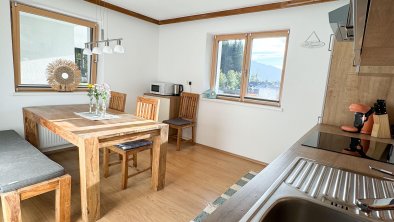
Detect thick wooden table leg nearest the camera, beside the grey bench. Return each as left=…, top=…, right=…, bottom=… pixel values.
left=79, top=138, right=100, bottom=222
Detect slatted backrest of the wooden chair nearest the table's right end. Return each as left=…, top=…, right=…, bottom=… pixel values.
left=135, top=96, right=160, bottom=121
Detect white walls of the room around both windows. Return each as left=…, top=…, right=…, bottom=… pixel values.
left=0, top=0, right=345, bottom=162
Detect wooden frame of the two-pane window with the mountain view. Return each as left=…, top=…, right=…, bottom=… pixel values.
left=210, top=29, right=290, bottom=107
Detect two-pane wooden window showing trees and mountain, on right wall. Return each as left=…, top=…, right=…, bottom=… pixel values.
left=211, top=30, right=289, bottom=106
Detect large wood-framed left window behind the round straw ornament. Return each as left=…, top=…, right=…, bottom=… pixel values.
left=12, top=3, right=97, bottom=91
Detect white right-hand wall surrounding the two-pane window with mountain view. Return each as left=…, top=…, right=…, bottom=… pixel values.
left=158, top=1, right=344, bottom=163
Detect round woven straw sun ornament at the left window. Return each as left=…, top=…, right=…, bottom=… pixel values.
left=47, top=59, right=81, bottom=92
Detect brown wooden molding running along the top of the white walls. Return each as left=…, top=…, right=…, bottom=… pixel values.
left=85, top=0, right=335, bottom=25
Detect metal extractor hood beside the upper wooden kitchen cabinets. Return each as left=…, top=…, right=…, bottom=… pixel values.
left=328, top=4, right=354, bottom=41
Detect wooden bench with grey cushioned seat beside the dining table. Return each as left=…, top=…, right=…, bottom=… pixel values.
left=0, top=130, right=71, bottom=222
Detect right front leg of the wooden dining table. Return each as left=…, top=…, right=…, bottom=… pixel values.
left=151, top=126, right=168, bottom=191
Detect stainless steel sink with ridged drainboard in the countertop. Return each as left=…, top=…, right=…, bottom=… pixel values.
left=241, top=158, right=394, bottom=222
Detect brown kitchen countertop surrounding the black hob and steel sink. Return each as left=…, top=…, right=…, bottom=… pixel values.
left=204, top=124, right=394, bottom=222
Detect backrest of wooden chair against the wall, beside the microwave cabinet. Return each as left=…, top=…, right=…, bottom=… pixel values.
left=179, top=92, right=200, bottom=121
